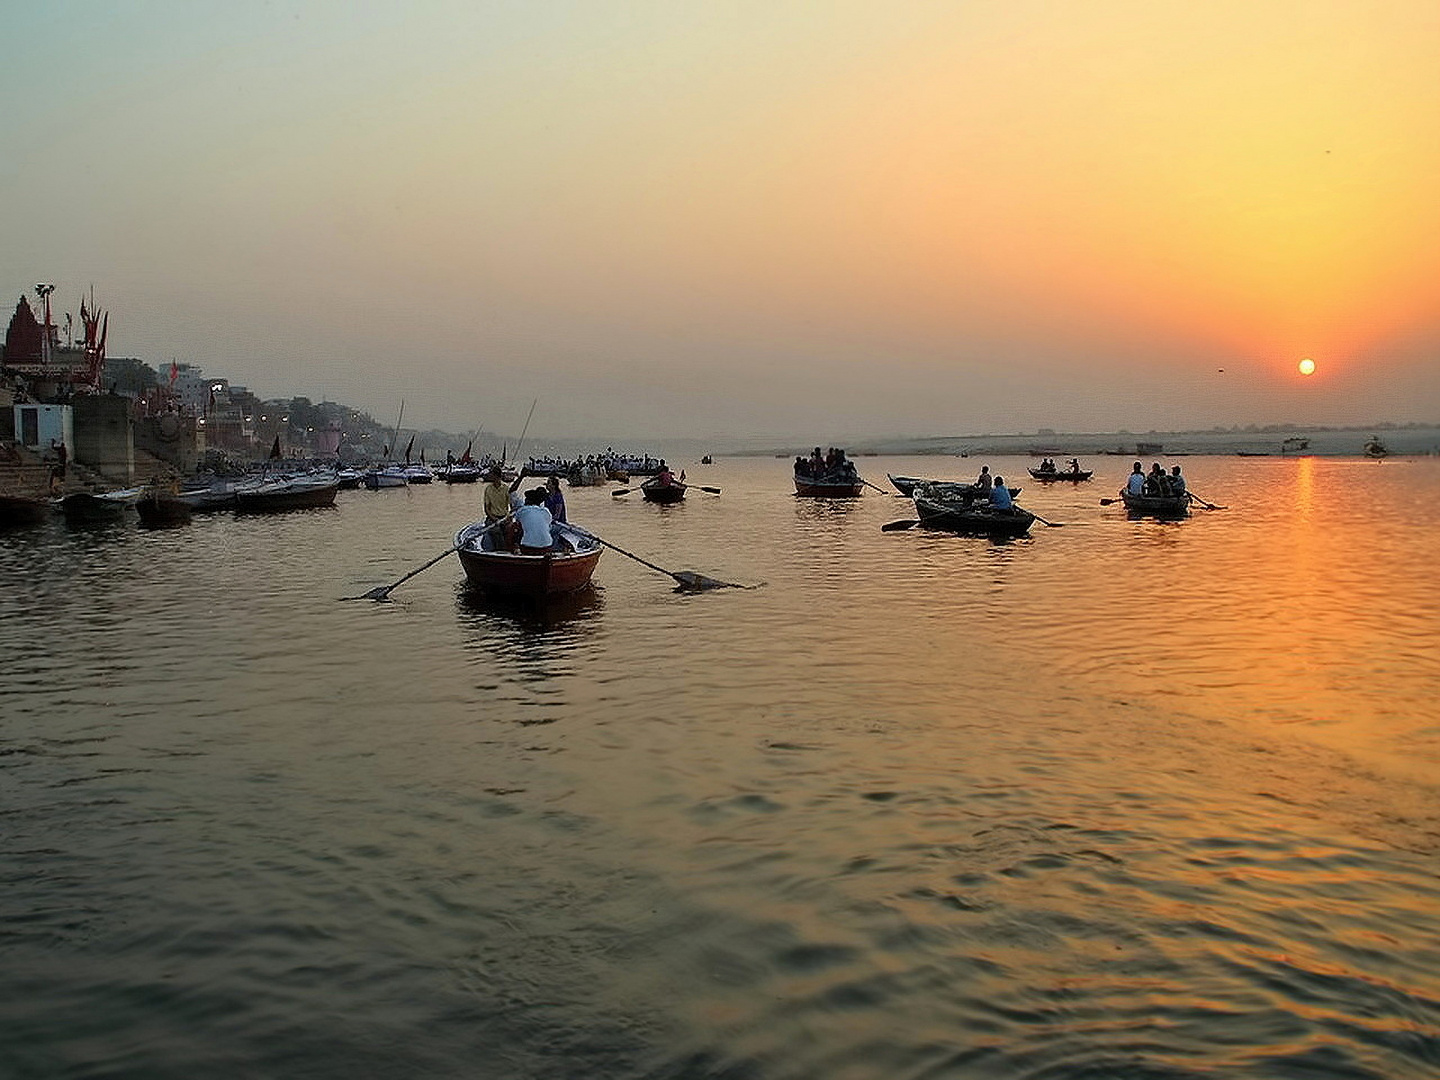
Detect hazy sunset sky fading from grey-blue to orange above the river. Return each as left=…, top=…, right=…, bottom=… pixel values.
left=0, top=0, right=1440, bottom=442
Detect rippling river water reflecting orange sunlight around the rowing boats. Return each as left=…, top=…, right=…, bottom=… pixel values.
left=0, top=456, right=1440, bottom=1080
